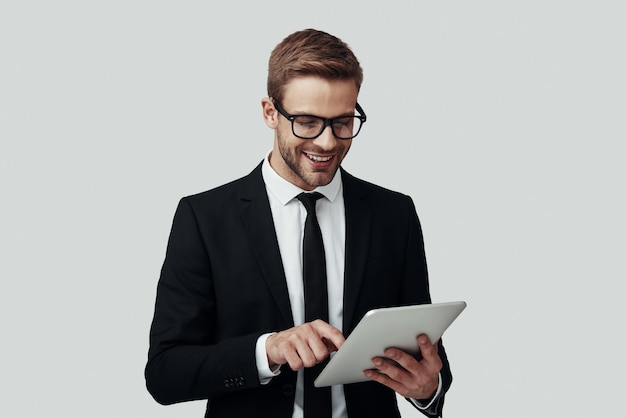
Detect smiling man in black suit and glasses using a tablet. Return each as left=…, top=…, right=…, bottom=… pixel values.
left=146, top=29, right=452, bottom=418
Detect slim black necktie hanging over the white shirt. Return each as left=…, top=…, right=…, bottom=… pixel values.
left=298, top=192, right=332, bottom=418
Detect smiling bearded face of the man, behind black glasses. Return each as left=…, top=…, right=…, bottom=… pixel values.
left=263, top=76, right=358, bottom=190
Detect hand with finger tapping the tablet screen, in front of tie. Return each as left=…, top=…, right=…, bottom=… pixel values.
left=265, top=319, right=346, bottom=371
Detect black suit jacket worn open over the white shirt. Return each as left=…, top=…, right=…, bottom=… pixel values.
left=145, top=165, right=452, bottom=418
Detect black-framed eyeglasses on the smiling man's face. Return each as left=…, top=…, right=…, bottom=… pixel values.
left=274, top=100, right=367, bottom=139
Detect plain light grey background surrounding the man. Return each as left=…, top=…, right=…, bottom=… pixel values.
left=0, top=0, right=626, bottom=418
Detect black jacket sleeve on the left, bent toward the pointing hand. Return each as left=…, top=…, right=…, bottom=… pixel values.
left=145, top=198, right=261, bottom=404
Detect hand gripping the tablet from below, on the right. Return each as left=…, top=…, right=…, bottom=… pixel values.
left=365, top=335, right=442, bottom=399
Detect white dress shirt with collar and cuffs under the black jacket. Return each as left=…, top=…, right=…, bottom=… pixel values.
left=256, top=154, right=442, bottom=418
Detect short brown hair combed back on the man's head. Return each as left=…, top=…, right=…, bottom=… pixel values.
left=267, top=29, right=363, bottom=101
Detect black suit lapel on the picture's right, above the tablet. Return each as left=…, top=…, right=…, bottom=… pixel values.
left=342, top=169, right=372, bottom=334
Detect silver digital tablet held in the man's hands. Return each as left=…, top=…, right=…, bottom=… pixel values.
left=315, top=301, right=466, bottom=387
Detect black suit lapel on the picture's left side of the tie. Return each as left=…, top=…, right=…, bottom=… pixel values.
left=240, top=164, right=293, bottom=327
